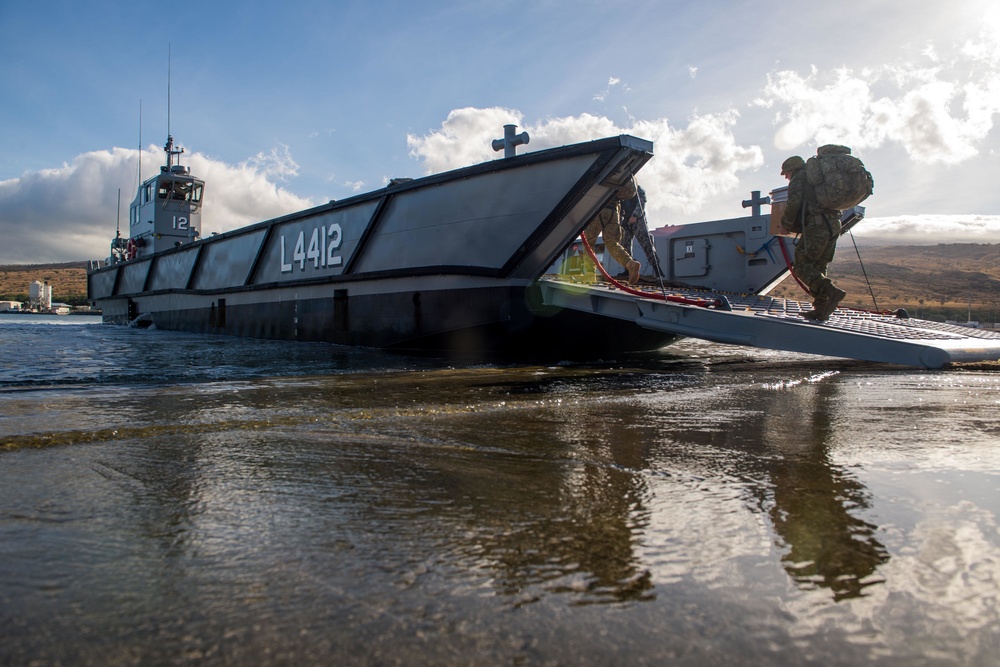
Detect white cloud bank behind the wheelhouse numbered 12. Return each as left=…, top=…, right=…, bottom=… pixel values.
left=0, top=147, right=312, bottom=264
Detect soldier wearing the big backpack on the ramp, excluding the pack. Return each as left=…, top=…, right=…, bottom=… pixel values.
left=781, top=155, right=847, bottom=322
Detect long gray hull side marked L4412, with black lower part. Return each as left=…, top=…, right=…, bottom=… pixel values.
left=88, top=136, right=676, bottom=356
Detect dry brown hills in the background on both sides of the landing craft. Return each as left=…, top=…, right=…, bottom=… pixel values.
left=0, top=247, right=1000, bottom=322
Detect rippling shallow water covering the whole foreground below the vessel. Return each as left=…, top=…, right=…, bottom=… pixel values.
left=0, top=316, right=1000, bottom=665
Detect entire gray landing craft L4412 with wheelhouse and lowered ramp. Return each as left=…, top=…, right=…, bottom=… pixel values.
left=88, top=128, right=1000, bottom=367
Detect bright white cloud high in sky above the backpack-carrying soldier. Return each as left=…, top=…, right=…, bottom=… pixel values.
left=752, top=30, right=1000, bottom=165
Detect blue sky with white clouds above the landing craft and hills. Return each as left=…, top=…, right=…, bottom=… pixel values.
left=0, top=0, right=1000, bottom=264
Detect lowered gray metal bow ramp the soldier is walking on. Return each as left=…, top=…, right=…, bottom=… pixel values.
left=538, top=276, right=1000, bottom=368
